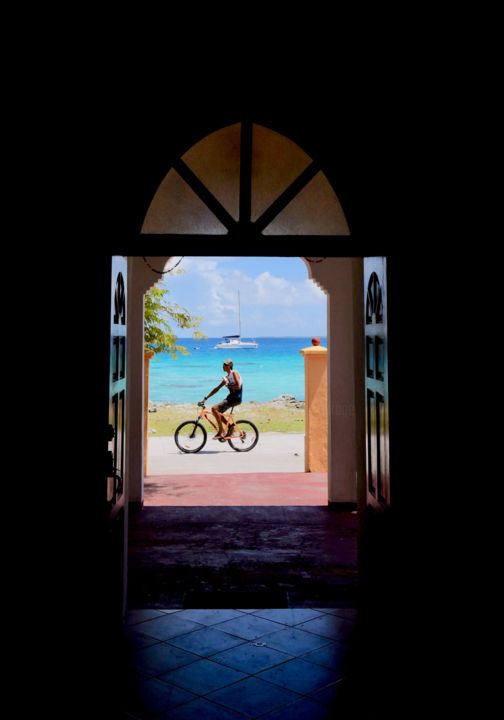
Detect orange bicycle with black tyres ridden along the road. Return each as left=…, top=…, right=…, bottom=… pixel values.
left=174, top=402, right=259, bottom=453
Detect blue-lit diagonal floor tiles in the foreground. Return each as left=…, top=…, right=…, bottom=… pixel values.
left=124, top=607, right=356, bottom=720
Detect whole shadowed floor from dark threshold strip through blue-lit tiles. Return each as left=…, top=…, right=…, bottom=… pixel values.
left=123, top=506, right=358, bottom=720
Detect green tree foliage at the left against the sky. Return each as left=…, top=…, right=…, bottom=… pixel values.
left=144, top=286, right=206, bottom=358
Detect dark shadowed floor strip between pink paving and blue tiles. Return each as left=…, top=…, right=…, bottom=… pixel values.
left=128, top=507, right=357, bottom=609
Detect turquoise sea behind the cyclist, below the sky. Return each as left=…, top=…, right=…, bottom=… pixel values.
left=149, top=337, right=327, bottom=403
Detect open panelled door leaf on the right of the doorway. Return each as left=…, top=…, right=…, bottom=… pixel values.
left=364, top=257, right=390, bottom=510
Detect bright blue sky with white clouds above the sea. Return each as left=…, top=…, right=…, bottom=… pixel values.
left=162, top=256, right=327, bottom=338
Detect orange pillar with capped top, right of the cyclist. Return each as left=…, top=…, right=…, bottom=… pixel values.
left=299, top=346, right=328, bottom=472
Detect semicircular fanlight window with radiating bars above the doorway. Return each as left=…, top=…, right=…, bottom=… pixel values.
left=142, top=122, right=350, bottom=239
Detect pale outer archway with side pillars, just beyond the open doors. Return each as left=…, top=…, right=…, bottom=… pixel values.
left=127, top=253, right=365, bottom=507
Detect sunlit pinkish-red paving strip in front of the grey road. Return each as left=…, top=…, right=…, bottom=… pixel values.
left=144, top=472, right=327, bottom=507
